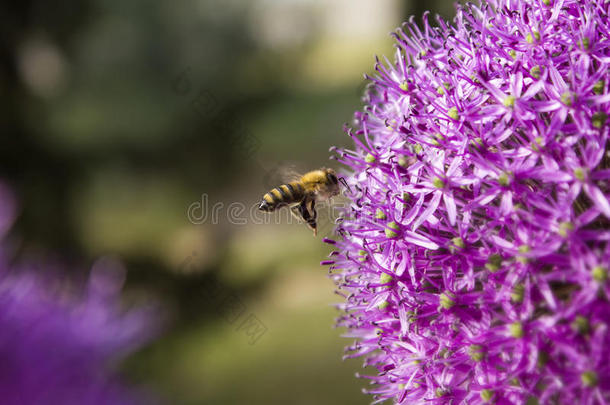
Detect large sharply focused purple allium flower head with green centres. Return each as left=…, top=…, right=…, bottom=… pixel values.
left=326, top=0, right=610, bottom=404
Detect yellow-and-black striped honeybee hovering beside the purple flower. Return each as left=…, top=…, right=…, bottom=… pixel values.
left=258, top=168, right=348, bottom=236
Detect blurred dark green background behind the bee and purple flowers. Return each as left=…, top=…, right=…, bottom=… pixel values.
left=0, top=0, right=453, bottom=404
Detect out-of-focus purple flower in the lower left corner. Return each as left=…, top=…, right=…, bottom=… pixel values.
left=0, top=184, right=158, bottom=405
